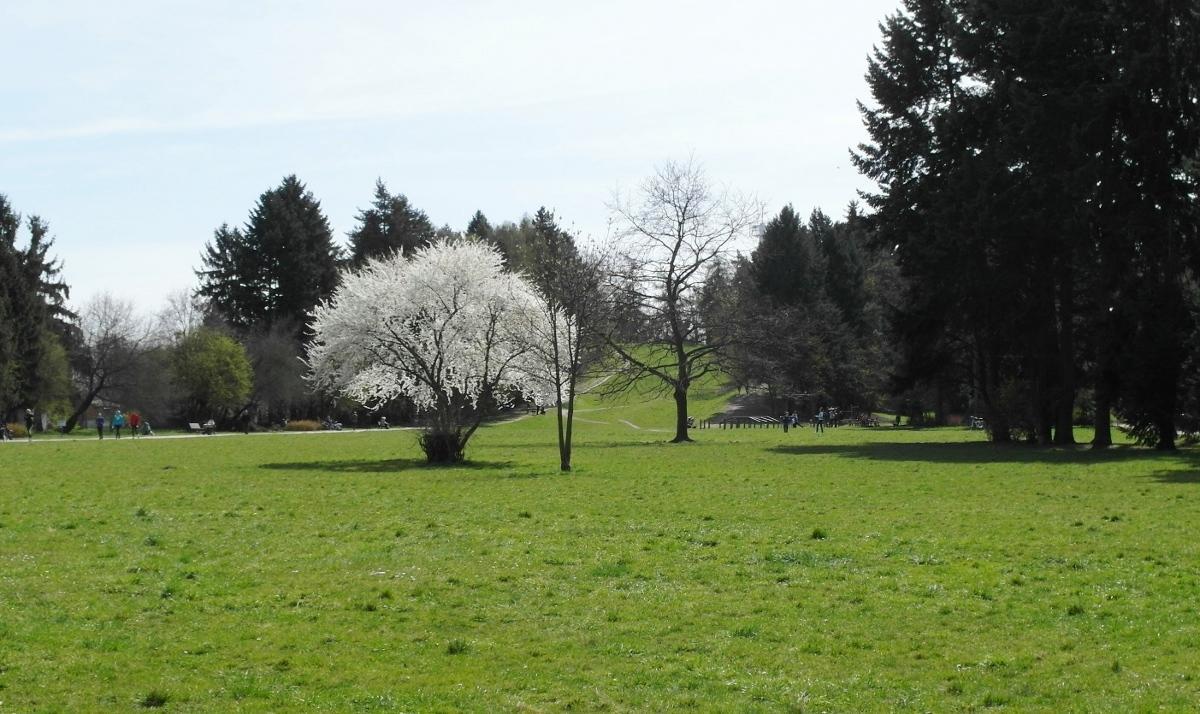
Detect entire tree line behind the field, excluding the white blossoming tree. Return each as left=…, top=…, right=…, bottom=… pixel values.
left=0, top=0, right=1200, bottom=456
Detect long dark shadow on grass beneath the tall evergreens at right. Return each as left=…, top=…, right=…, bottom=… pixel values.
left=772, top=442, right=1200, bottom=474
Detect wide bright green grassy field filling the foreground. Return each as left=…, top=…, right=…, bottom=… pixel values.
left=0, top=394, right=1200, bottom=712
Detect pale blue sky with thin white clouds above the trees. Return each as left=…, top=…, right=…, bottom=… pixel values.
left=0, top=0, right=899, bottom=313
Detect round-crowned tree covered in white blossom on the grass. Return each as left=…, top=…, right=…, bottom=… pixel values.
left=307, top=240, right=550, bottom=463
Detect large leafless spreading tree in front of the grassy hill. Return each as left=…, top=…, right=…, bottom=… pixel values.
left=607, top=160, right=760, bottom=442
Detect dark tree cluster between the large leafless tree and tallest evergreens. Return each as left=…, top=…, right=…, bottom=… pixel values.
left=701, top=205, right=896, bottom=412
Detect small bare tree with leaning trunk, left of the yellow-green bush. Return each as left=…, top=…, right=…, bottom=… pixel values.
left=66, top=293, right=151, bottom=431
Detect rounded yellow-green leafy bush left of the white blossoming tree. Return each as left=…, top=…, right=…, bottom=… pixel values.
left=173, top=328, right=252, bottom=419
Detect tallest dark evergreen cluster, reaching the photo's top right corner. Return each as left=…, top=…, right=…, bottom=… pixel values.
left=856, top=0, right=1200, bottom=448
